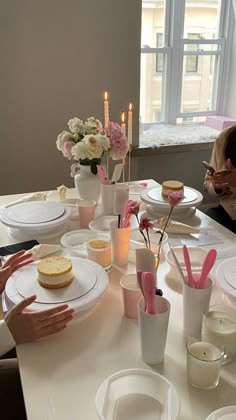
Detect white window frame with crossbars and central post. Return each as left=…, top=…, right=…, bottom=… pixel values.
left=141, top=0, right=232, bottom=124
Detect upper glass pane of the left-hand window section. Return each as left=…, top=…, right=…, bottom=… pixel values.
left=141, top=0, right=165, bottom=48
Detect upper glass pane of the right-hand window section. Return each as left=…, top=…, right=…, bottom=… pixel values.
left=183, top=0, right=221, bottom=39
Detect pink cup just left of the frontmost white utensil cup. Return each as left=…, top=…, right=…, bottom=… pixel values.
left=120, top=274, right=142, bottom=319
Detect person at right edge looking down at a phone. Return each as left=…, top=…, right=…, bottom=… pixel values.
left=204, top=125, right=236, bottom=233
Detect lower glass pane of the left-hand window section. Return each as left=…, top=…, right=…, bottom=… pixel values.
left=140, top=53, right=164, bottom=123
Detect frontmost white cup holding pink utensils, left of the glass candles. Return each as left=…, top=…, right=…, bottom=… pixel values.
left=138, top=296, right=170, bottom=365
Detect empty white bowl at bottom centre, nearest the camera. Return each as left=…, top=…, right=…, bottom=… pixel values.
left=96, top=369, right=180, bottom=420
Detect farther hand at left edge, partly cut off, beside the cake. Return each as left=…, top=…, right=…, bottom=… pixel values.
left=0, top=250, right=33, bottom=294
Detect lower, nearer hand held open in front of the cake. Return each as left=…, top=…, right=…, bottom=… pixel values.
left=5, top=295, right=74, bottom=344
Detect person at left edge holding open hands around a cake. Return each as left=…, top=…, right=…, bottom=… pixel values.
left=0, top=251, right=74, bottom=420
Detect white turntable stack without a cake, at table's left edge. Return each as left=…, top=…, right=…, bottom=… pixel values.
left=0, top=201, right=72, bottom=241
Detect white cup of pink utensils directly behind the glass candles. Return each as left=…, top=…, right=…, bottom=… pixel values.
left=183, top=277, right=213, bottom=340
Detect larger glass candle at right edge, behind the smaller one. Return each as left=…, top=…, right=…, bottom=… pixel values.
left=202, top=305, right=236, bottom=363
